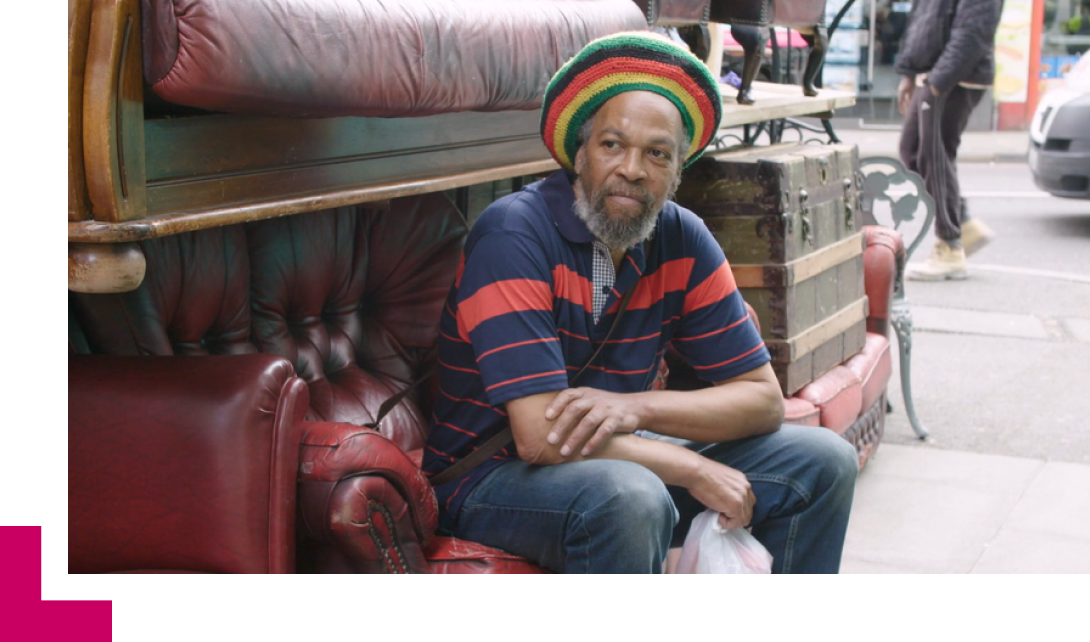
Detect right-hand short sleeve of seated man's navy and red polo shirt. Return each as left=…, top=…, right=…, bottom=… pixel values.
left=674, top=217, right=772, bottom=384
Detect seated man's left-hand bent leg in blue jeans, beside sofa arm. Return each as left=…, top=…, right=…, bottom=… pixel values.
left=450, top=461, right=677, bottom=574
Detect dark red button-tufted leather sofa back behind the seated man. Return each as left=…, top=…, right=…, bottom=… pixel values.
left=69, top=194, right=467, bottom=452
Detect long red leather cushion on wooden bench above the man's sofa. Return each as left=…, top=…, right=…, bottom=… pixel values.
left=143, top=0, right=647, bottom=118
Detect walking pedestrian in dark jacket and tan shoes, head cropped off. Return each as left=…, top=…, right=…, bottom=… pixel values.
left=896, top=0, right=1003, bottom=281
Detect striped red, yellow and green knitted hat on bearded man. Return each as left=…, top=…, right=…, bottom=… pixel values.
left=542, top=32, right=723, bottom=171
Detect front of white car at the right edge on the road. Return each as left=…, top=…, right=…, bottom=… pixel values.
left=1029, top=53, right=1090, bottom=198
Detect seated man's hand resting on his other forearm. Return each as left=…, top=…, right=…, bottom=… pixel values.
left=545, top=388, right=640, bottom=458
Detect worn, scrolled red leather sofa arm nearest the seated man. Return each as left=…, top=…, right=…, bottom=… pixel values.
left=299, top=423, right=439, bottom=573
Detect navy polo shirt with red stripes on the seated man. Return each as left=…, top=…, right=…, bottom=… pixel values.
left=424, top=170, right=771, bottom=519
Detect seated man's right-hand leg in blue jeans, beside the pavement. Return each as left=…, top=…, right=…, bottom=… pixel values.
left=649, top=426, right=859, bottom=574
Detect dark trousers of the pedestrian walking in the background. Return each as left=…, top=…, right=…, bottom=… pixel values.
left=900, top=80, right=984, bottom=242
